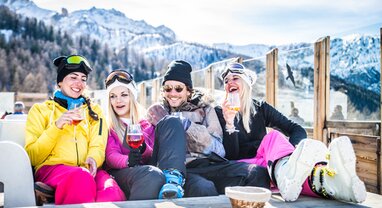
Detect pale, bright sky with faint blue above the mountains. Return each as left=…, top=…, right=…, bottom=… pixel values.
left=33, top=0, right=382, bottom=45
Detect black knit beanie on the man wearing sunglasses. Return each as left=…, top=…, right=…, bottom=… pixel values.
left=162, top=60, right=192, bottom=89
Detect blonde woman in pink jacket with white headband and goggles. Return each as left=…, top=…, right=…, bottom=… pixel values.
left=106, top=70, right=165, bottom=200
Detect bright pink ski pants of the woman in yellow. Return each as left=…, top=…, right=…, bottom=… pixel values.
left=35, top=164, right=126, bottom=204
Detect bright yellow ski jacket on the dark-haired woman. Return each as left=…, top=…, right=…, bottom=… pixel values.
left=25, top=100, right=108, bottom=171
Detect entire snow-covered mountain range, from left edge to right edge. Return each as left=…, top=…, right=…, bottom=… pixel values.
left=0, top=0, right=381, bottom=116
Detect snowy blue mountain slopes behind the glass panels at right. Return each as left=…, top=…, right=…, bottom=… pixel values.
left=216, top=34, right=381, bottom=119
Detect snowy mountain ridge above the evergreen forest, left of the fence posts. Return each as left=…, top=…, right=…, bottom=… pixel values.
left=0, top=0, right=242, bottom=68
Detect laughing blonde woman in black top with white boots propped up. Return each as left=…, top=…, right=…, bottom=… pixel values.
left=216, top=63, right=366, bottom=202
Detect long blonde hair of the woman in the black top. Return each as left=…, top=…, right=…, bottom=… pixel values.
left=240, top=77, right=256, bottom=133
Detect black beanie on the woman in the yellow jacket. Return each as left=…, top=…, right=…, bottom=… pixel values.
left=53, top=56, right=91, bottom=84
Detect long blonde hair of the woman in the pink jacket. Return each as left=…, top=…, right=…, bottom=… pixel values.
left=108, top=88, right=146, bottom=142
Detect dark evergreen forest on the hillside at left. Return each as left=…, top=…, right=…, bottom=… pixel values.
left=0, top=5, right=155, bottom=93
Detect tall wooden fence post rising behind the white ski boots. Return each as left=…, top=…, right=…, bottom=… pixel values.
left=313, top=36, right=330, bottom=144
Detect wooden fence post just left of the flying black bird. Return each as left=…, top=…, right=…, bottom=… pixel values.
left=265, top=48, right=278, bottom=107
